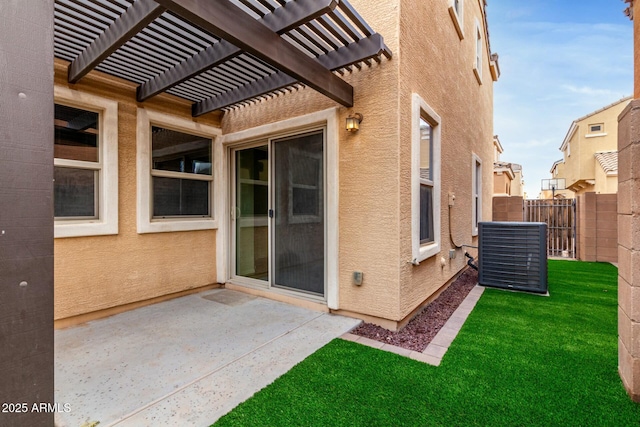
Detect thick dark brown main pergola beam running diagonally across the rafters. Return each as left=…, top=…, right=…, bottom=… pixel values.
left=157, top=0, right=353, bottom=107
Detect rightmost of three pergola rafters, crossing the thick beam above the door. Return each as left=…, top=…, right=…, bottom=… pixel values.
left=192, top=33, right=388, bottom=117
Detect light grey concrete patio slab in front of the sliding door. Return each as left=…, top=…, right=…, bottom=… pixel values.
left=55, top=289, right=359, bottom=427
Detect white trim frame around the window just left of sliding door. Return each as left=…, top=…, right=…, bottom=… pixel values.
left=136, top=108, right=225, bottom=234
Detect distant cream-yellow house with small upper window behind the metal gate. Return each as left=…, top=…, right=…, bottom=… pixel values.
left=559, top=97, right=631, bottom=195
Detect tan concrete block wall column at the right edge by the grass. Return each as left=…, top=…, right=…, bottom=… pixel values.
left=618, top=100, right=640, bottom=402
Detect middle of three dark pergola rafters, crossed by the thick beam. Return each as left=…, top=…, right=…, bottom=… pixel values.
left=136, top=0, right=337, bottom=102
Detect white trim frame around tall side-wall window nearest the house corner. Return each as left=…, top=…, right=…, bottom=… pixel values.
left=411, top=93, right=442, bottom=263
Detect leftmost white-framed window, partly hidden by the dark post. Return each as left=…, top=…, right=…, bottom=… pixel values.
left=53, top=86, right=118, bottom=237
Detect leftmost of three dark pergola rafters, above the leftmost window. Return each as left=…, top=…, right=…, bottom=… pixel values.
left=68, top=0, right=165, bottom=83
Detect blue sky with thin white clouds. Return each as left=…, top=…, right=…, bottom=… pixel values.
left=487, top=0, right=633, bottom=198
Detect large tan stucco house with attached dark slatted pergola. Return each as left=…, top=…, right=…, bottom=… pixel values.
left=54, top=0, right=500, bottom=328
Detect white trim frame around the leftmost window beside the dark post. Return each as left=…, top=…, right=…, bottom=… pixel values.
left=53, top=86, right=118, bottom=238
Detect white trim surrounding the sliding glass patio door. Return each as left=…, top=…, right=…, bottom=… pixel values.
left=216, top=108, right=344, bottom=310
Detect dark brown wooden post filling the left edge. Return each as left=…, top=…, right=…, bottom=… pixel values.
left=0, top=0, right=54, bottom=427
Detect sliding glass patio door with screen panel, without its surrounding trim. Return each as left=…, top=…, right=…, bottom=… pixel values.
left=232, top=130, right=325, bottom=297
